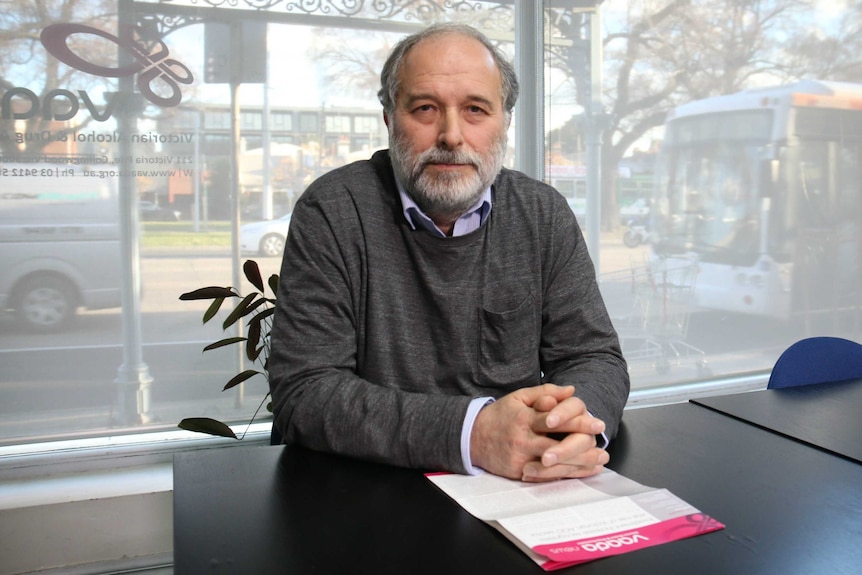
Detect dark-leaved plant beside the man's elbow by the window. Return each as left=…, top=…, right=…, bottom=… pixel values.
left=179, top=260, right=278, bottom=439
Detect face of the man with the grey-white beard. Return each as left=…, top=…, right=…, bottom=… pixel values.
left=386, top=31, right=508, bottom=224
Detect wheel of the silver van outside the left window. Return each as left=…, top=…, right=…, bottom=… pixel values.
left=15, top=276, right=77, bottom=333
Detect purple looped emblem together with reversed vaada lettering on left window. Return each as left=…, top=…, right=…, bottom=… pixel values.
left=0, top=22, right=194, bottom=122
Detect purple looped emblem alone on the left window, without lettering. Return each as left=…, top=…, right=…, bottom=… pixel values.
left=40, top=23, right=194, bottom=108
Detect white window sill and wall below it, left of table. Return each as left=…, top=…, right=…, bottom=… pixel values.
left=0, top=422, right=271, bottom=575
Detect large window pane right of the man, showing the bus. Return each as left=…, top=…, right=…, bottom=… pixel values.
left=544, top=0, right=862, bottom=390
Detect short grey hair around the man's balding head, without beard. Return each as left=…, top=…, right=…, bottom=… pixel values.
left=377, top=22, right=520, bottom=118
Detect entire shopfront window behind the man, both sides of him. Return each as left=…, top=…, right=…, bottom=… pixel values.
left=0, top=0, right=862, bottom=460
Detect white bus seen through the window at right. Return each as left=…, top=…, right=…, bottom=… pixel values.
left=636, top=83, right=862, bottom=388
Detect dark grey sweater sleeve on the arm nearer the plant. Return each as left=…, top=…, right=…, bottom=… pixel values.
left=269, top=182, right=470, bottom=472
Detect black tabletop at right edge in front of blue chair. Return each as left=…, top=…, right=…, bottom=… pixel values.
left=691, top=379, right=862, bottom=464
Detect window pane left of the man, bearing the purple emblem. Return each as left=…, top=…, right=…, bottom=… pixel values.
left=0, top=0, right=514, bottom=444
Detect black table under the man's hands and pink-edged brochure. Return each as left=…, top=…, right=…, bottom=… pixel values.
left=174, top=404, right=862, bottom=575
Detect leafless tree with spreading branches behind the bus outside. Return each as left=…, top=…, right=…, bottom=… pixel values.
left=552, top=0, right=811, bottom=229
